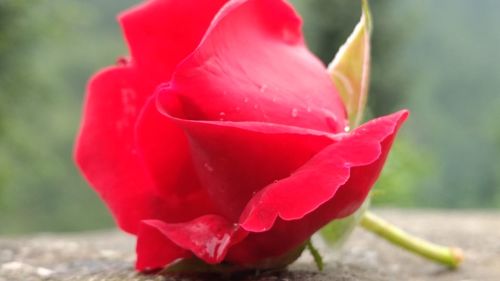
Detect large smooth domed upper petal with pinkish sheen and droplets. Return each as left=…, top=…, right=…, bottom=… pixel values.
left=160, top=0, right=346, bottom=132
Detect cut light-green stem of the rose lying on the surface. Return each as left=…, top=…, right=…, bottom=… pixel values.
left=360, top=211, right=463, bottom=268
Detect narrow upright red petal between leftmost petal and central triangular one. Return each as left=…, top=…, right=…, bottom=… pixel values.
left=136, top=99, right=214, bottom=222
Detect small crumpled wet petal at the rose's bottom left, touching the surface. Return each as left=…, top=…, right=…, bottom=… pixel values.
left=136, top=215, right=247, bottom=270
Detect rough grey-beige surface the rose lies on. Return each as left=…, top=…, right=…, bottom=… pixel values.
left=0, top=210, right=500, bottom=281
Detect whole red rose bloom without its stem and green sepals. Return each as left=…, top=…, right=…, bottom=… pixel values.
left=76, top=0, right=407, bottom=270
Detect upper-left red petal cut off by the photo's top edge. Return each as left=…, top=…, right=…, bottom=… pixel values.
left=119, top=0, right=226, bottom=80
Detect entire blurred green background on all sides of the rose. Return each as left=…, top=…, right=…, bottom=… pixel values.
left=0, top=0, right=500, bottom=234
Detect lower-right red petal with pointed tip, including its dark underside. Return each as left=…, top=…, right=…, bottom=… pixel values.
left=228, top=111, right=408, bottom=263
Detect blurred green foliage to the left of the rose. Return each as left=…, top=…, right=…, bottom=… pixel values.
left=0, top=0, right=141, bottom=232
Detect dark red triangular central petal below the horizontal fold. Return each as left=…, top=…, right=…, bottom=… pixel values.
left=158, top=91, right=333, bottom=221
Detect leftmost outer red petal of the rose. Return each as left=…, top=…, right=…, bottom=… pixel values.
left=75, top=67, right=166, bottom=233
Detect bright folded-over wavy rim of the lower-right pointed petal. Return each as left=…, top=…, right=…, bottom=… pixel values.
left=240, top=110, right=409, bottom=232
